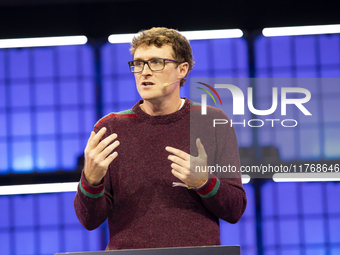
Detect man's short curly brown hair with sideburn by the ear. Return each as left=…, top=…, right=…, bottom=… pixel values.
left=130, top=27, right=195, bottom=87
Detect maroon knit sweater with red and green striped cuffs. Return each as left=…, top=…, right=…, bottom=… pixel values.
left=74, top=99, right=246, bottom=250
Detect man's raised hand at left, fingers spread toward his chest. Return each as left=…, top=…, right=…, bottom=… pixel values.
left=84, top=127, right=119, bottom=186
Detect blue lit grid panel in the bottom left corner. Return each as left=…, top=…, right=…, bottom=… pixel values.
left=0, top=192, right=104, bottom=255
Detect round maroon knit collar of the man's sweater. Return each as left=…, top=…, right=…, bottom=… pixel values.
left=132, top=97, right=192, bottom=124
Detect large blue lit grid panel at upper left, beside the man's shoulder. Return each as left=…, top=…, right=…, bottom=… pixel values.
left=0, top=45, right=96, bottom=173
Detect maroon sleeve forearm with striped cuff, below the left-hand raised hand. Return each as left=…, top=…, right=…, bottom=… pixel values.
left=74, top=125, right=113, bottom=230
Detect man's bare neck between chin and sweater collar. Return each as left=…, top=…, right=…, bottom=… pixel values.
left=140, top=97, right=182, bottom=116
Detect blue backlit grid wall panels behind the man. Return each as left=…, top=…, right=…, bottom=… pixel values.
left=0, top=34, right=340, bottom=255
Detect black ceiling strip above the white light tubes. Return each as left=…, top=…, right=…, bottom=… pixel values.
left=0, top=0, right=340, bottom=38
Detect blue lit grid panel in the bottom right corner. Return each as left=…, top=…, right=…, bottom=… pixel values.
left=261, top=182, right=340, bottom=254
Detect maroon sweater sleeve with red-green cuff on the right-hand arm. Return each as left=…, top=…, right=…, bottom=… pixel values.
left=196, top=109, right=247, bottom=223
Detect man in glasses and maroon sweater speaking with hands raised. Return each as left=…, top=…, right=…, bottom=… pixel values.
left=74, top=28, right=246, bottom=250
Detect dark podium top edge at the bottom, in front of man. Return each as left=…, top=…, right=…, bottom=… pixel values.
left=55, top=245, right=241, bottom=255
